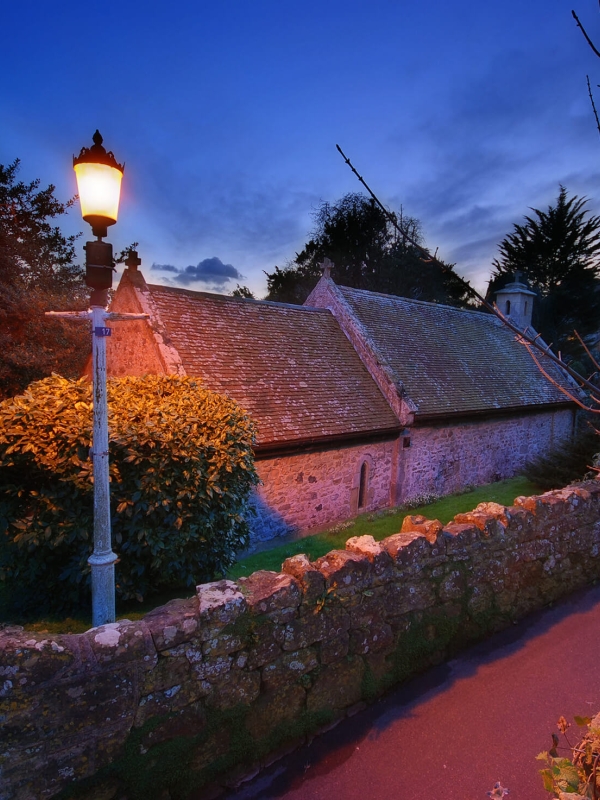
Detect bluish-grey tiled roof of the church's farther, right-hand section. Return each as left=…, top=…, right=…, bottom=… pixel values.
left=337, top=286, right=569, bottom=418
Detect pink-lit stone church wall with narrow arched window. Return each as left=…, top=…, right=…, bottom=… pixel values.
left=248, top=440, right=397, bottom=542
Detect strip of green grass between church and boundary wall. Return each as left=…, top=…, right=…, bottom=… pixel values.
left=0, top=478, right=540, bottom=634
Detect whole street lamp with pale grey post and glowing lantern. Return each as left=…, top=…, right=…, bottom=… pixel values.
left=47, top=131, right=148, bottom=627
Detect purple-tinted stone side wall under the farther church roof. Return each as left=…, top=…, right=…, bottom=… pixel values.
left=400, top=409, right=574, bottom=501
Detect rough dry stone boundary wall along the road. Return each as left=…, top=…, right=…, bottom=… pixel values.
left=0, top=481, right=600, bottom=800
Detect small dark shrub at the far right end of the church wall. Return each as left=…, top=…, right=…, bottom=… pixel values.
left=525, top=427, right=600, bottom=491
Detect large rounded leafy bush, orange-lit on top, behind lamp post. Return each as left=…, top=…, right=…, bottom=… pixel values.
left=0, top=375, right=258, bottom=611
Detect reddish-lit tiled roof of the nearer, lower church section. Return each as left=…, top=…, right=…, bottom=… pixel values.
left=148, top=285, right=399, bottom=446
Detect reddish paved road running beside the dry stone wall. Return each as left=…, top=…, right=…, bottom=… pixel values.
left=227, top=586, right=600, bottom=800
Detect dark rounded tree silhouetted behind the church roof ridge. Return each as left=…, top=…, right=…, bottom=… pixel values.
left=267, top=194, right=476, bottom=306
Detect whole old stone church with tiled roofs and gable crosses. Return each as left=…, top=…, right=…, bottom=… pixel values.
left=107, top=267, right=575, bottom=540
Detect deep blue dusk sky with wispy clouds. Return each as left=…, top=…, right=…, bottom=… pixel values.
left=0, top=0, right=600, bottom=297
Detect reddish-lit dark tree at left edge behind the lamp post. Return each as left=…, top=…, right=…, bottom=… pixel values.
left=0, top=161, right=90, bottom=399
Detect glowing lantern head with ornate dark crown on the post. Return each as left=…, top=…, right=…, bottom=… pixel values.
left=73, top=131, right=125, bottom=239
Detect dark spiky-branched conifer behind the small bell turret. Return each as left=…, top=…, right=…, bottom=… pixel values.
left=488, top=186, right=600, bottom=359
